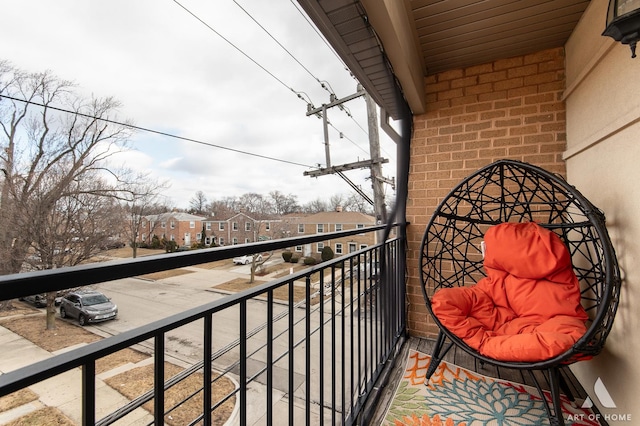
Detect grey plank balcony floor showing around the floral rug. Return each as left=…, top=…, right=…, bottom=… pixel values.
left=370, top=337, right=608, bottom=426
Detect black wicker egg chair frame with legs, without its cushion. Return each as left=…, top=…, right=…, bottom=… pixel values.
left=420, top=160, right=621, bottom=425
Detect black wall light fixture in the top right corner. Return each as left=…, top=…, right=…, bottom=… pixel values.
left=602, top=0, right=640, bottom=58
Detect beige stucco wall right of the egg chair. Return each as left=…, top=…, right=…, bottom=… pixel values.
left=564, top=0, right=640, bottom=425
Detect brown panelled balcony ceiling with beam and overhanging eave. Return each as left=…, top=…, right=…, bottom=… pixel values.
left=298, top=0, right=592, bottom=118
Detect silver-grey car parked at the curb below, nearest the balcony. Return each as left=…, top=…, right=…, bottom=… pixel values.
left=60, top=290, right=118, bottom=325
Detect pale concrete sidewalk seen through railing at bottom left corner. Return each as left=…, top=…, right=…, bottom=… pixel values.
left=0, top=326, right=153, bottom=426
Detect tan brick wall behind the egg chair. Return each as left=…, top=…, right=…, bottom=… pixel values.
left=407, top=48, right=566, bottom=336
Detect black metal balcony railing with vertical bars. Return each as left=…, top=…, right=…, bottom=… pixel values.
left=0, top=226, right=405, bottom=425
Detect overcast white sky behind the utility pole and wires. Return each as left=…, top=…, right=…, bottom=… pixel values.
left=0, top=0, right=395, bottom=208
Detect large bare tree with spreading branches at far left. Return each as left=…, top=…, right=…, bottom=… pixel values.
left=0, top=62, right=139, bottom=326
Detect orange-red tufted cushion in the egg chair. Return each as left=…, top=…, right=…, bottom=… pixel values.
left=431, top=222, right=587, bottom=362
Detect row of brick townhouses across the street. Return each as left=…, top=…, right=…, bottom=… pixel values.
left=138, top=208, right=376, bottom=256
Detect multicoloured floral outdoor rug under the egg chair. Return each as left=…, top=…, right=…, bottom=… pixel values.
left=383, top=351, right=600, bottom=426
